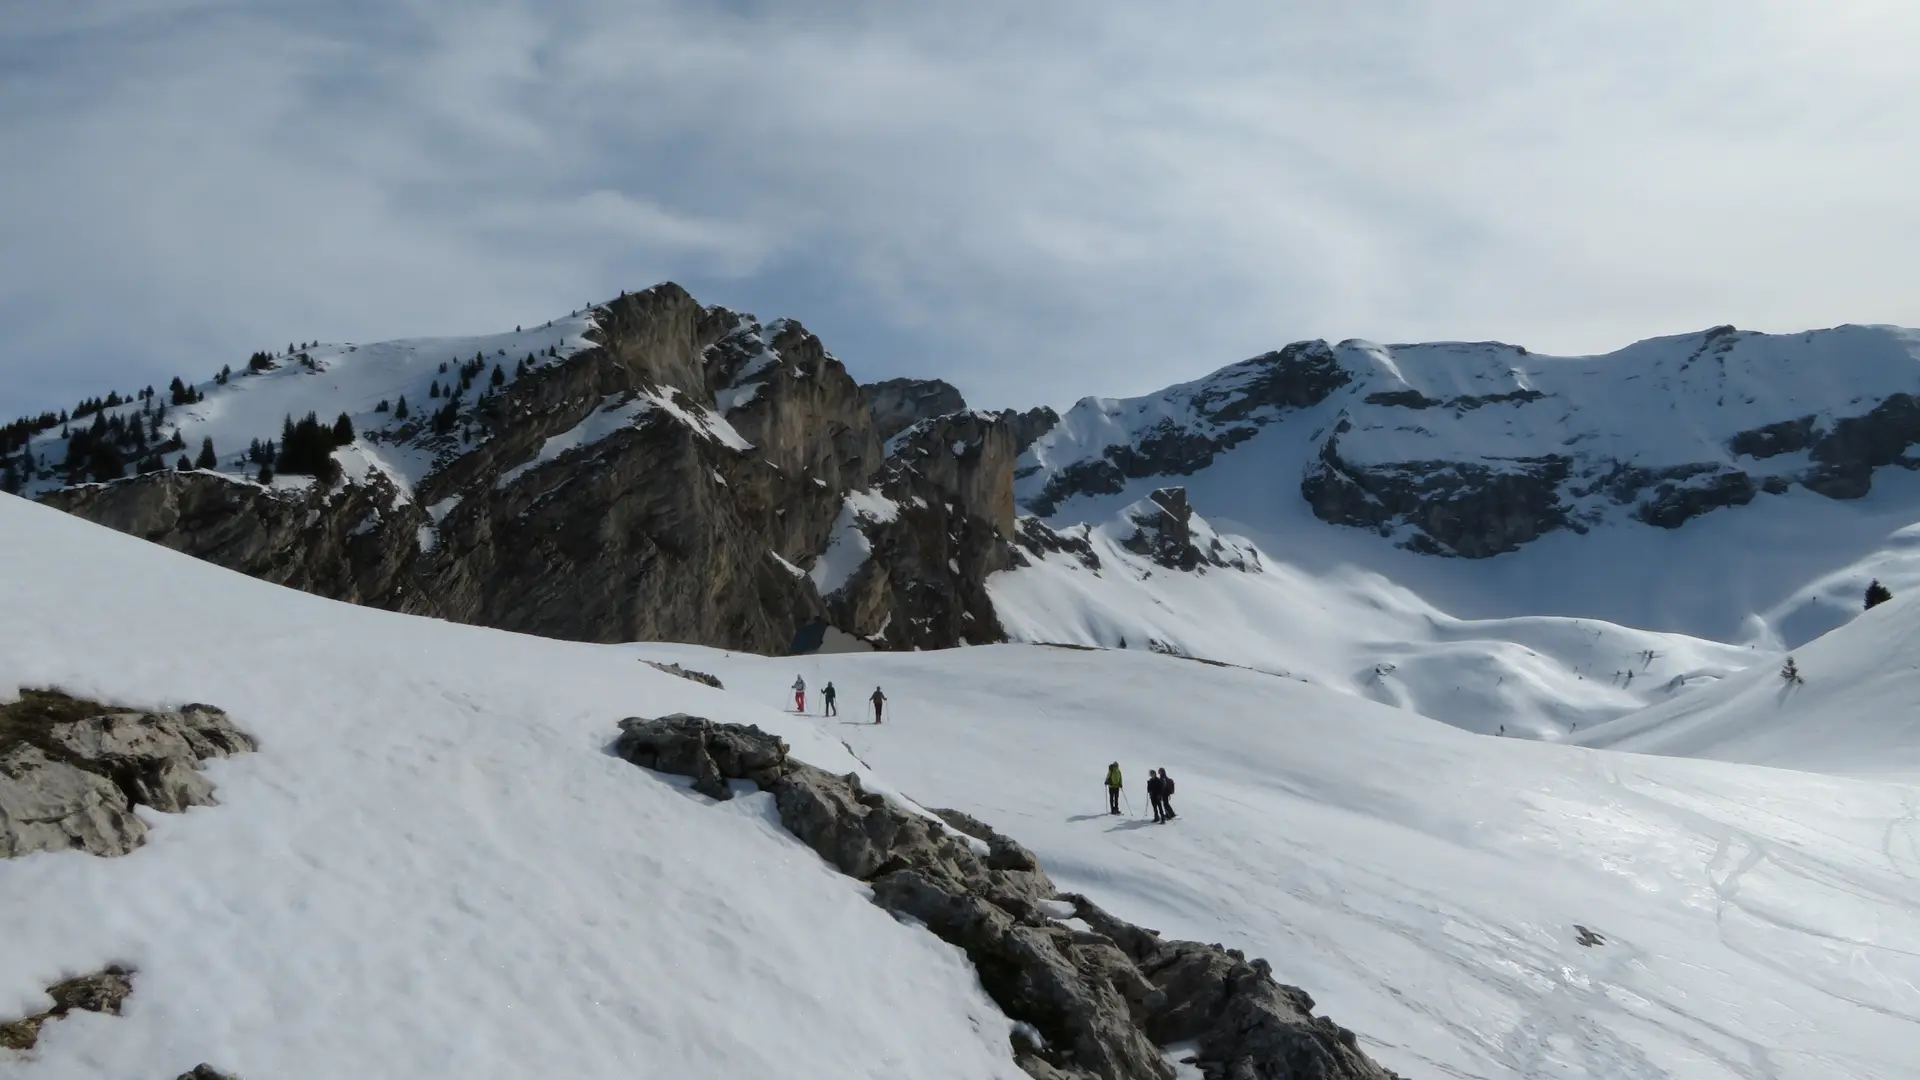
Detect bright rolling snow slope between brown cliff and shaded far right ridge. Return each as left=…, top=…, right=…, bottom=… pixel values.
left=987, top=503, right=1774, bottom=738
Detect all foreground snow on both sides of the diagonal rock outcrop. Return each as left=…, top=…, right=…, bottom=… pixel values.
left=0, top=498, right=1920, bottom=1080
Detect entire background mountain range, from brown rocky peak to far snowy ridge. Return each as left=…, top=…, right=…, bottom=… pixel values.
left=15, top=284, right=1920, bottom=738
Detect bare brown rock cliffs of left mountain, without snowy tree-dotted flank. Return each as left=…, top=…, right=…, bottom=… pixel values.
left=30, top=284, right=1014, bottom=653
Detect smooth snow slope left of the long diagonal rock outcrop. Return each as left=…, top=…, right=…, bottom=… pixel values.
left=0, top=496, right=1023, bottom=1080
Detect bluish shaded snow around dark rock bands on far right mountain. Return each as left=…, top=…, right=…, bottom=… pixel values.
left=1020, top=319, right=1920, bottom=648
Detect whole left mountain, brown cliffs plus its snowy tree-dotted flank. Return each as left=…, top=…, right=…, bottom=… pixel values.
left=8, top=284, right=1052, bottom=653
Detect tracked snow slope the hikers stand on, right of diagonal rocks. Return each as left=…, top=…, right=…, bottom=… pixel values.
left=636, top=638, right=1920, bottom=1080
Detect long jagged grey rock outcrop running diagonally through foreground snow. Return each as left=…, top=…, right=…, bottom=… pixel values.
left=614, top=715, right=1392, bottom=1080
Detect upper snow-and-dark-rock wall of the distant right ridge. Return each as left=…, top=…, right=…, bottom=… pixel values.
left=1020, top=327, right=1920, bottom=559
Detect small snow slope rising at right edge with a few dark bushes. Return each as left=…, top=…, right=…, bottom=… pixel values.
left=1576, top=594, right=1920, bottom=778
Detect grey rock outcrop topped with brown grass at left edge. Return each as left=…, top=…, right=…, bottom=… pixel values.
left=0, top=690, right=255, bottom=857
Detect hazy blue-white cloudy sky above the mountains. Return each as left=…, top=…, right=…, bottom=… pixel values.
left=0, top=0, right=1920, bottom=415
